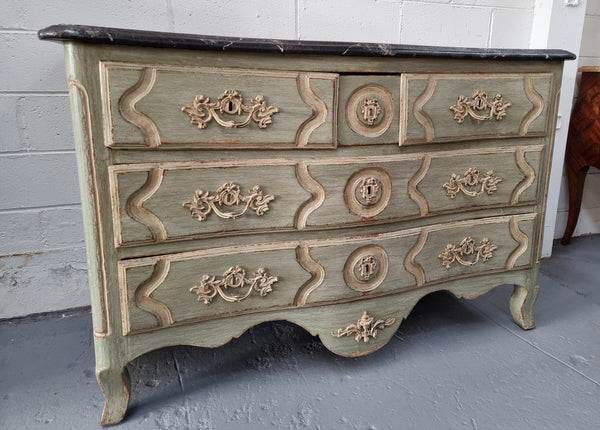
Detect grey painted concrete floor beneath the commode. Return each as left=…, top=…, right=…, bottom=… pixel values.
left=0, top=236, right=600, bottom=430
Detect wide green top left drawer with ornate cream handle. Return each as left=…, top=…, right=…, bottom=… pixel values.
left=100, top=61, right=338, bottom=149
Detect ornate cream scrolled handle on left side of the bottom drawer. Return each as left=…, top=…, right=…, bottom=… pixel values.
left=190, top=266, right=278, bottom=305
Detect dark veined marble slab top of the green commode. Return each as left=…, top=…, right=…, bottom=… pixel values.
left=38, top=24, right=576, bottom=60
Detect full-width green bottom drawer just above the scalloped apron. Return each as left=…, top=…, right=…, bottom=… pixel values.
left=119, top=214, right=537, bottom=334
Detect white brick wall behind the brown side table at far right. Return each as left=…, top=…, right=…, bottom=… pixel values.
left=554, top=0, right=600, bottom=239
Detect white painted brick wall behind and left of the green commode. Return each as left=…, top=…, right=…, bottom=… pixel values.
left=0, top=0, right=564, bottom=318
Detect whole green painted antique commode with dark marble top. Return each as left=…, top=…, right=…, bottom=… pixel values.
left=39, top=25, right=574, bottom=424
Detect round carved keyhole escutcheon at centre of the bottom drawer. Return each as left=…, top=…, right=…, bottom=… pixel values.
left=344, top=245, right=389, bottom=292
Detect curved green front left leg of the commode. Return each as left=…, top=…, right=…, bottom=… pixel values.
left=96, top=366, right=131, bottom=426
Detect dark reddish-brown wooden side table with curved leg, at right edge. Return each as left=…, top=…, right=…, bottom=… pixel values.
left=562, top=66, right=600, bottom=245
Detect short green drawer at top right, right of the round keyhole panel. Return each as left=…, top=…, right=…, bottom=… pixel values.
left=400, top=73, right=552, bottom=145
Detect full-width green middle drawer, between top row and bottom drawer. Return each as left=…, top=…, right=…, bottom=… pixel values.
left=109, top=145, right=544, bottom=246
